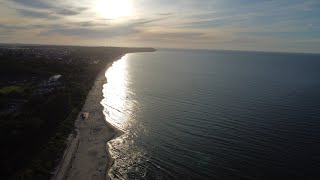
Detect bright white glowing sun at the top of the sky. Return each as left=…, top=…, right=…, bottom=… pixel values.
left=95, top=0, right=132, bottom=19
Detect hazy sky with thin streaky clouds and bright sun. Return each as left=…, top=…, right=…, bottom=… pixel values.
left=0, top=0, right=320, bottom=53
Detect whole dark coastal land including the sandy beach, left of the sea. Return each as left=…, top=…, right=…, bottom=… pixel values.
left=0, top=44, right=155, bottom=179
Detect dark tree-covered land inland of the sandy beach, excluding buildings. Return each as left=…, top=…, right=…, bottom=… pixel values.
left=0, top=47, right=156, bottom=179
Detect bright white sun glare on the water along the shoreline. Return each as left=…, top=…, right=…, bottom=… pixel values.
left=101, top=55, right=147, bottom=179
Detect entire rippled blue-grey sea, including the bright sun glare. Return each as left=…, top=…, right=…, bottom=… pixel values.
left=101, top=50, right=320, bottom=179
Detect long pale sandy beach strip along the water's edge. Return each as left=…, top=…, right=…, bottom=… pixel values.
left=53, top=61, right=121, bottom=180
